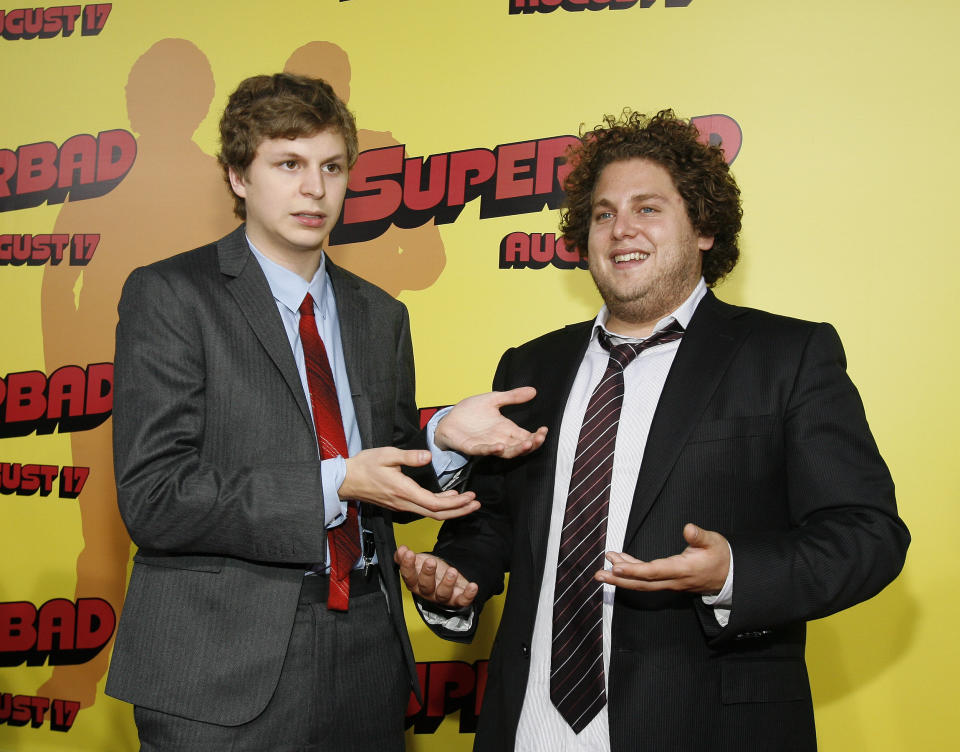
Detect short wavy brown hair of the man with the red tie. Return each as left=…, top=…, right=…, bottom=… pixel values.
left=217, top=73, right=359, bottom=219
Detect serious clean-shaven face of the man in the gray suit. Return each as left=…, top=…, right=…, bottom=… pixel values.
left=230, top=130, right=347, bottom=278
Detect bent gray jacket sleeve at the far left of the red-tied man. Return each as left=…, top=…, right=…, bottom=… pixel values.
left=113, top=269, right=324, bottom=564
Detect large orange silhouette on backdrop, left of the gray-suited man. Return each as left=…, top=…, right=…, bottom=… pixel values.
left=37, top=39, right=237, bottom=707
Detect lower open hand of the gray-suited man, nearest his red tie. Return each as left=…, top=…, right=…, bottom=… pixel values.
left=338, top=447, right=480, bottom=520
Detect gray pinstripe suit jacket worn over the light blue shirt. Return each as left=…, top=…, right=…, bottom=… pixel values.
left=106, top=227, right=435, bottom=725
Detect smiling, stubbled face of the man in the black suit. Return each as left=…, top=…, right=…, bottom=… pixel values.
left=587, top=159, right=713, bottom=337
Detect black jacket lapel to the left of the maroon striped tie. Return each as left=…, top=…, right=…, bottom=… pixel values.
left=517, top=321, right=593, bottom=578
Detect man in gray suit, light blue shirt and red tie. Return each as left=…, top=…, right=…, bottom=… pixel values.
left=106, top=74, right=545, bottom=752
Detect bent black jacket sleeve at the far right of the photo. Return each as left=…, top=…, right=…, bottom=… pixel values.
left=716, top=324, right=910, bottom=640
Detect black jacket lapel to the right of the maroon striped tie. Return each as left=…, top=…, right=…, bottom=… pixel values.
left=624, top=292, right=744, bottom=550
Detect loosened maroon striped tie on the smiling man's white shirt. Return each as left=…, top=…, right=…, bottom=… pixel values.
left=550, top=322, right=683, bottom=734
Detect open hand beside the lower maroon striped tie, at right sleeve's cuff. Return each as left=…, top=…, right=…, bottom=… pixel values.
left=594, top=523, right=730, bottom=595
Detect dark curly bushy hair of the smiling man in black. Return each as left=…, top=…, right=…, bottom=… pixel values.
left=560, top=109, right=743, bottom=287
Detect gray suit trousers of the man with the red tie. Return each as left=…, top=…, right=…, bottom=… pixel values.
left=134, top=577, right=410, bottom=752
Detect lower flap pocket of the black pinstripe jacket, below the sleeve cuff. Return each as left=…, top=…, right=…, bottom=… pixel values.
left=720, top=658, right=810, bottom=705
